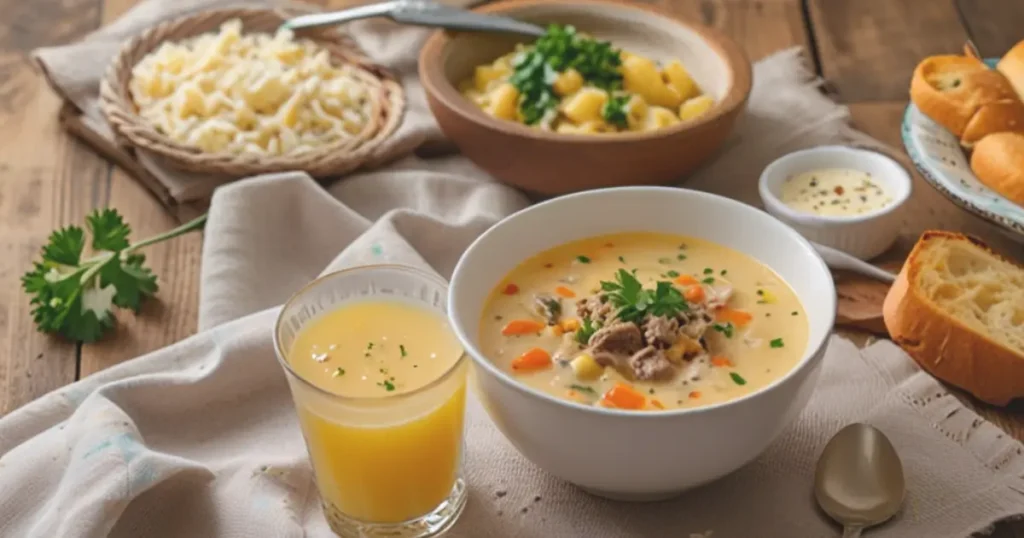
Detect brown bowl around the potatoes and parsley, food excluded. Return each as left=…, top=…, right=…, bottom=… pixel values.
left=420, top=0, right=751, bottom=195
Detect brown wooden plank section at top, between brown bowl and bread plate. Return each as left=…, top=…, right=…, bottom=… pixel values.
left=807, top=0, right=967, bottom=102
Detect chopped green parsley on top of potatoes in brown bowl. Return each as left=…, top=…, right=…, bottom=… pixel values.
left=509, top=25, right=623, bottom=125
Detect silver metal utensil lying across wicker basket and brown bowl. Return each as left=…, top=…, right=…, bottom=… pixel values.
left=282, top=0, right=544, bottom=37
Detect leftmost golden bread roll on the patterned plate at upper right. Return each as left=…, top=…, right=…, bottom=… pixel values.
left=910, top=55, right=1024, bottom=147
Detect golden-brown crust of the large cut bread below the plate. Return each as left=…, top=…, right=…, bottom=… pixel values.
left=882, top=231, right=1024, bottom=406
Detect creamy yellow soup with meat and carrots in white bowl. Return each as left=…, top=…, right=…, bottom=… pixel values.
left=479, top=233, right=808, bottom=410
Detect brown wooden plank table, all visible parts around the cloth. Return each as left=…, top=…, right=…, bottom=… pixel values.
left=0, top=0, right=1024, bottom=537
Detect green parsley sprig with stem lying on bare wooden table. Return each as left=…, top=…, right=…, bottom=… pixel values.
left=22, top=209, right=206, bottom=342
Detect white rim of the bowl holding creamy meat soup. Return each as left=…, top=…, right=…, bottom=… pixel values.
left=447, top=185, right=838, bottom=420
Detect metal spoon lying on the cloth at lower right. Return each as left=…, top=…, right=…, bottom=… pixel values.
left=814, top=423, right=906, bottom=538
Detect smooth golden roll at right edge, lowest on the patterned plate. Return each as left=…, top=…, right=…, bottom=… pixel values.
left=971, top=132, right=1024, bottom=207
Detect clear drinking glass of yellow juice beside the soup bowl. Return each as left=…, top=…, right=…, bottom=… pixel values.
left=274, top=265, right=469, bottom=538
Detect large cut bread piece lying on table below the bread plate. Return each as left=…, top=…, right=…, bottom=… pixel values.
left=882, top=232, right=1024, bottom=406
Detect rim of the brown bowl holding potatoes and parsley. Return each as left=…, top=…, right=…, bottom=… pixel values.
left=419, top=0, right=753, bottom=143
